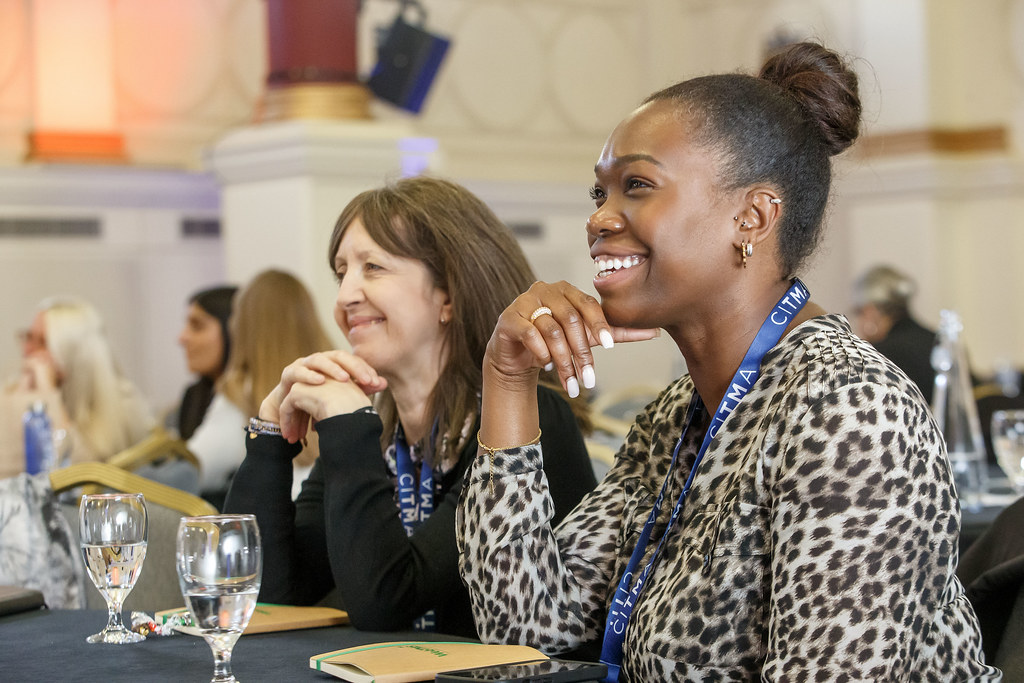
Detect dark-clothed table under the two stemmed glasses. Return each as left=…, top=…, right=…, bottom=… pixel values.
left=0, top=609, right=468, bottom=683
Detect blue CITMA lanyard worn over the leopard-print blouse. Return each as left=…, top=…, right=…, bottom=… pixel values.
left=601, top=280, right=810, bottom=683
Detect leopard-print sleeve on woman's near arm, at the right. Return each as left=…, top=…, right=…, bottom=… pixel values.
left=762, top=378, right=998, bottom=681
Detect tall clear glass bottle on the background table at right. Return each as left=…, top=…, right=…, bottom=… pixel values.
left=932, top=310, right=988, bottom=512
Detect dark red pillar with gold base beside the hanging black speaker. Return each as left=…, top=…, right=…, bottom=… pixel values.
left=257, top=0, right=370, bottom=121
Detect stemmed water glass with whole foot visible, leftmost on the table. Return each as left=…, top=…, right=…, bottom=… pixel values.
left=79, top=494, right=150, bottom=644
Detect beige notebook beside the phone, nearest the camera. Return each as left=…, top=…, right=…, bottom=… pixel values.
left=309, top=641, right=548, bottom=683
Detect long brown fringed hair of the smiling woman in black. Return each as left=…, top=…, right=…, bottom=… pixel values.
left=328, top=176, right=589, bottom=462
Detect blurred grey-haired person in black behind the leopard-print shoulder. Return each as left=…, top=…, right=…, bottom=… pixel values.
left=853, top=265, right=935, bottom=405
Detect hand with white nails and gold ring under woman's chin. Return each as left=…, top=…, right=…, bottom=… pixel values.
left=483, top=281, right=658, bottom=397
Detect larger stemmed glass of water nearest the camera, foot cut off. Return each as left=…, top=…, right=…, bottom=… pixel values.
left=177, top=515, right=263, bottom=683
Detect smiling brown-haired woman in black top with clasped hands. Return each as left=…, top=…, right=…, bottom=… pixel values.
left=225, top=177, right=596, bottom=636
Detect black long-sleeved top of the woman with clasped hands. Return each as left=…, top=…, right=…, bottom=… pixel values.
left=225, top=388, right=596, bottom=631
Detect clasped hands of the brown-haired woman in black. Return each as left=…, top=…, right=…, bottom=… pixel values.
left=259, top=349, right=387, bottom=442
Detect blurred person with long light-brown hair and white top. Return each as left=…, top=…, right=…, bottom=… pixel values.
left=187, top=270, right=332, bottom=509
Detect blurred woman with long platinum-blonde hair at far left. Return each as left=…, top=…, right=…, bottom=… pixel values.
left=0, top=297, right=155, bottom=476
